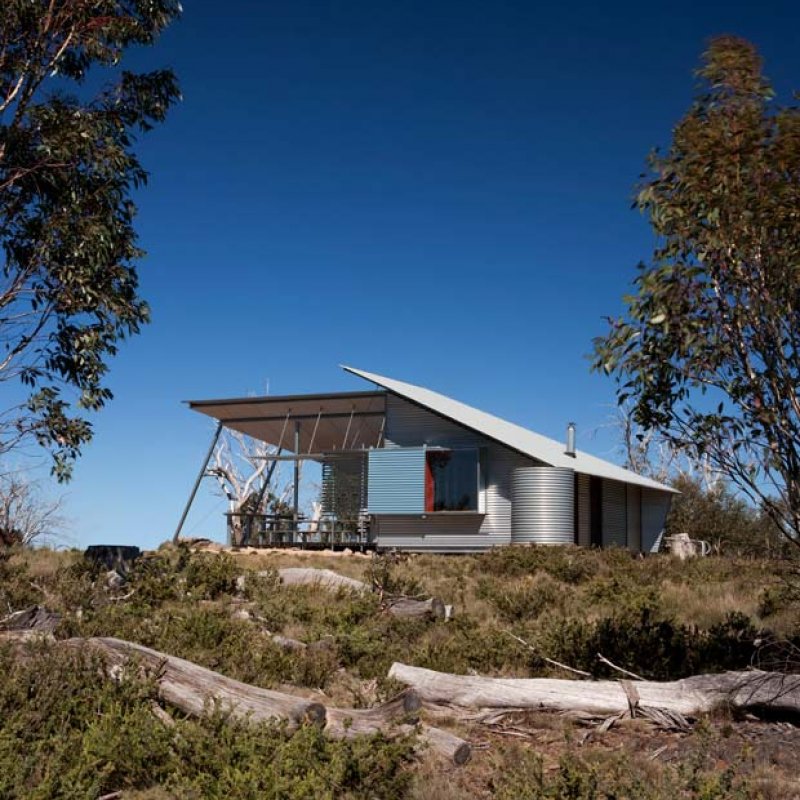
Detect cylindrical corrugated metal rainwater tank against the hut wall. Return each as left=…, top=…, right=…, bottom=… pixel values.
left=511, top=467, right=575, bottom=544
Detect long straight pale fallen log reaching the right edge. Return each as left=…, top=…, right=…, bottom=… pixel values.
left=389, top=662, right=800, bottom=718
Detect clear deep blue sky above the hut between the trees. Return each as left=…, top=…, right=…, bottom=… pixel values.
left=36, top=0, right=800, bottom=546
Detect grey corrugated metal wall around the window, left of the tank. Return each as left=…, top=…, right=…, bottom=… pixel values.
left=378, top=394, right=537, bottom=549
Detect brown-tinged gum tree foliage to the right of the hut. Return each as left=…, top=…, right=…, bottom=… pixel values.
left=593, top=37, right=800, bottom=545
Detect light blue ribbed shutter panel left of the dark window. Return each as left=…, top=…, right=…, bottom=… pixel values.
left=367, top=447, right=425, bottom=514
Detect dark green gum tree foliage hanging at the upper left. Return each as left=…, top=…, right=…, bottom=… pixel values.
left=0, top=0, right=180, bottom=479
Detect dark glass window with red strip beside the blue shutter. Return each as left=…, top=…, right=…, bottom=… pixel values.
left=425, top=450, right=480, bottom=512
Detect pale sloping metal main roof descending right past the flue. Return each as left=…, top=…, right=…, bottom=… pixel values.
left=342, top=365, right=675, bottom=492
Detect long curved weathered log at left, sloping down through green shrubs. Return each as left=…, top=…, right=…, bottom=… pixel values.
left=71, top=637, right=326, bottom=728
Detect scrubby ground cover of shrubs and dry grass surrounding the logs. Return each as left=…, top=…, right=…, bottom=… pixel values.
left=0, top=546, right=800, bottom=800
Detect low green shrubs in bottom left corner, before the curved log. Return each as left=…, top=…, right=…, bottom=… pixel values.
left=0, top=645, right=413, bottom=800
